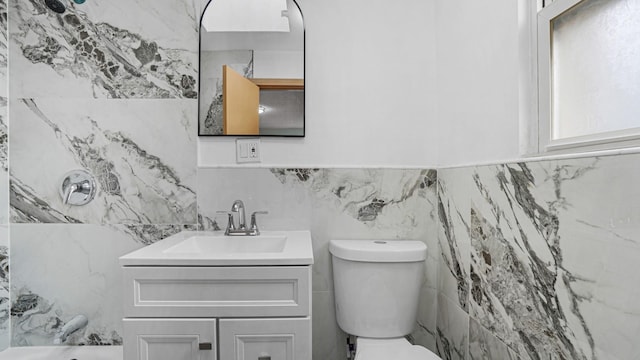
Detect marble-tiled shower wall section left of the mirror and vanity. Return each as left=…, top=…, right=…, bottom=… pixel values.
left=6, top=0, right=200, bottom=346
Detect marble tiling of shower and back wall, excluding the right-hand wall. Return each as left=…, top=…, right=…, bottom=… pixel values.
left=0, top=0, right=437, bottom=359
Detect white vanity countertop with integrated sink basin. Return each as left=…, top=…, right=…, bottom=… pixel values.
left=120, top=231, right=313, bottom=266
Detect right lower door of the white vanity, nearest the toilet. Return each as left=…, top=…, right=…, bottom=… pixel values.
left=219, top=317, right=311, bottom=360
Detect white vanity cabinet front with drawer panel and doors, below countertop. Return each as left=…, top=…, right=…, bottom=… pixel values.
left=122, top=265, right=311, bottom=360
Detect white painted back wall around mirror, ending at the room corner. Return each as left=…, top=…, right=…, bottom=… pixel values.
left=198, top=0, right=440, bottom=167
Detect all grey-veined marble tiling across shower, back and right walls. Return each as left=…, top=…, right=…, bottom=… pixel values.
left=5, top=0, right=640, bottom=360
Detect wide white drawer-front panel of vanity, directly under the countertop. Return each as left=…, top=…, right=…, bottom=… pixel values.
left=123, top=266, right=311, bottom=317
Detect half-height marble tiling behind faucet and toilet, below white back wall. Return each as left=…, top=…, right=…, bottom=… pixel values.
left=198, top=168, right=438, bottom=360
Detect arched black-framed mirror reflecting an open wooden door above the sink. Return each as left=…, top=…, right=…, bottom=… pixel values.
left=198, top=0, right=305, bottom=137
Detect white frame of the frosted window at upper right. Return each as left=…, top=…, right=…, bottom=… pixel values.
left=519, top=0, right=640, bottom=156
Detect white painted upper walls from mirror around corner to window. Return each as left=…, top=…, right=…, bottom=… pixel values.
left=199, top=0, right=528, bottom=167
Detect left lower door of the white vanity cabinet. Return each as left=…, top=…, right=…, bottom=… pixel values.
left=123, top=319, right=216, bottom=360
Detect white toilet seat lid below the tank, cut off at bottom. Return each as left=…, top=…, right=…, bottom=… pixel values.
left=355, top=337, right=441, bottom=360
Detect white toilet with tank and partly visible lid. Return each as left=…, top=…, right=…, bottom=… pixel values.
left=329, top=240, right=440, bottom=360
